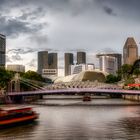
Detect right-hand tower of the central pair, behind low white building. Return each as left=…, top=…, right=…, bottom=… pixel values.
left=77, top=52, right=86, bottom=64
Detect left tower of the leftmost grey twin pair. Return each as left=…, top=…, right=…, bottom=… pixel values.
left=38, top=51, right=48, bottom=74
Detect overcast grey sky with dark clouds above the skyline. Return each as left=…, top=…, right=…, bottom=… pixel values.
left=0, top=0, right=140, bottom=76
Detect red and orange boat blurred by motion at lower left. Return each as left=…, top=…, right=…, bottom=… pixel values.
left=0, top=107, right=39, bottom=128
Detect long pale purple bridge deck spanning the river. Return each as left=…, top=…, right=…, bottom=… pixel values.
left=7, top=88, right=140, bottom=96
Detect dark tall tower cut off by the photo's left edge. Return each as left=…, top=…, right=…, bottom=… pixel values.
left=0, top=34, right=6, bottom=67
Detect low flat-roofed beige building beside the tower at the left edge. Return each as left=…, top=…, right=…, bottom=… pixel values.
left=7, top=64, right=25, bottom=72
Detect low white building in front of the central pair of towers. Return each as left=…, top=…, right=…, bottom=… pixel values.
left=70, top=64, right=95, bottom=74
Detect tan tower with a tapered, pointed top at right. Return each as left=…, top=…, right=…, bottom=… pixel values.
left=123, top=37, right=138, bottom=65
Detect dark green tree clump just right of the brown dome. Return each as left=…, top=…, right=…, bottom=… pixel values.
left=106, top=74, right=121, bottom=83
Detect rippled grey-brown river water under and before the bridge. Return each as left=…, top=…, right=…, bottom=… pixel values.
left=0, top=98, right=140, bottom=140
